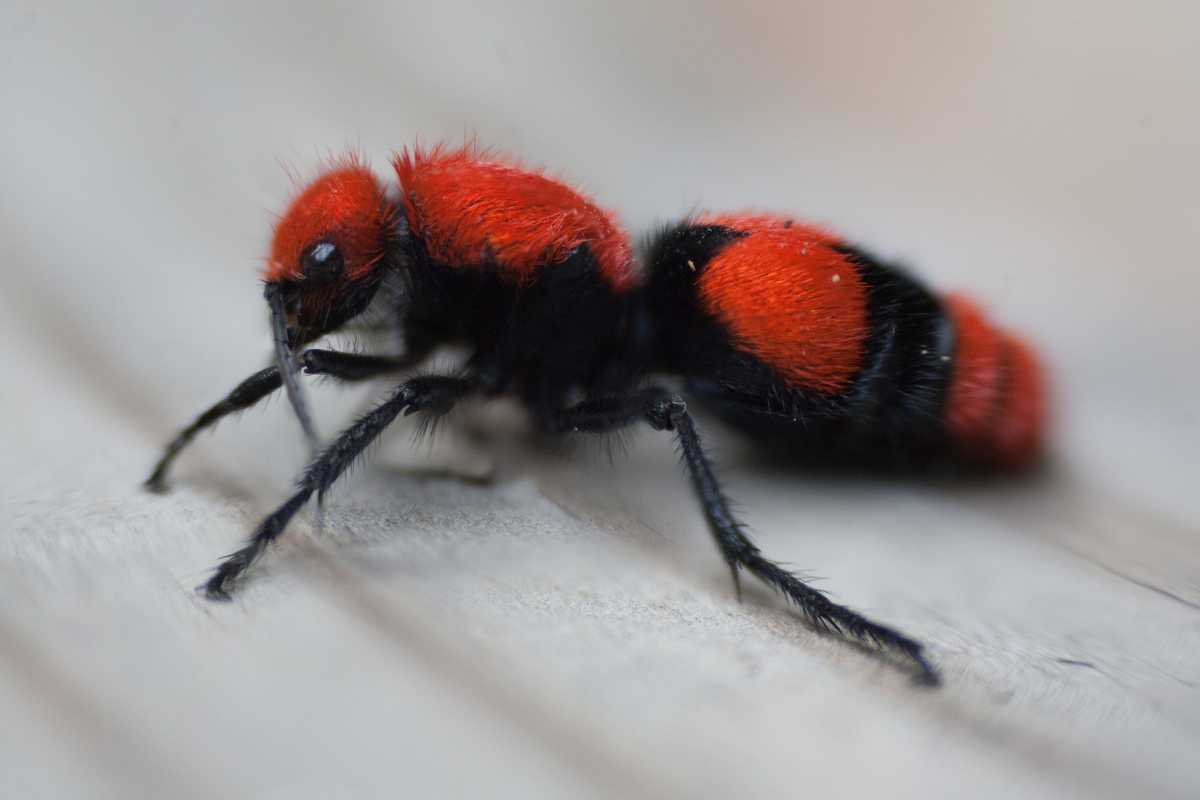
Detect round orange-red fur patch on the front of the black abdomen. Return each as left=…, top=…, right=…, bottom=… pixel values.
left=698, top=215, right=868, bottom=395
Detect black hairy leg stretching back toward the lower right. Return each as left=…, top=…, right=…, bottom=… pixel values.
left=546, top=387, right=941, bottom=686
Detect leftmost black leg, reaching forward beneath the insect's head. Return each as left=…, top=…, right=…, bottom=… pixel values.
left=144, top=350, right=416, bottom=492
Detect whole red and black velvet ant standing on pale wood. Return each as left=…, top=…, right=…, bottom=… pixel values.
left=146, top=146, right=1044, bottom=684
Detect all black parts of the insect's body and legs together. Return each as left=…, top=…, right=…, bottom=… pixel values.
left=150, top=209, right=950, bottom=684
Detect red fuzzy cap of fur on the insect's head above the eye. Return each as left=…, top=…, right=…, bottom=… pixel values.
left=263, top=158, right=390, bottom=282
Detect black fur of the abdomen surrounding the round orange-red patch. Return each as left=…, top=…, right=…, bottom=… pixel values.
left=647, top=223, right=954, bottom=468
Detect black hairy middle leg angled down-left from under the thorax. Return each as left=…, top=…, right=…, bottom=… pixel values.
left=204, top=375, right=478, bottom=600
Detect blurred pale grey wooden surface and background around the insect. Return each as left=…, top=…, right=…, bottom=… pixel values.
left=0, top=0, right=1200, bottom=798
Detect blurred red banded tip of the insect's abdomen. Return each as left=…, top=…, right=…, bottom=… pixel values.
left=946, top=295, right=1046, bottom=467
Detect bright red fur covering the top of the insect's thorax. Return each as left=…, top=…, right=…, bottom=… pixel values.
left=392, top=146, right=637, bottom=290
